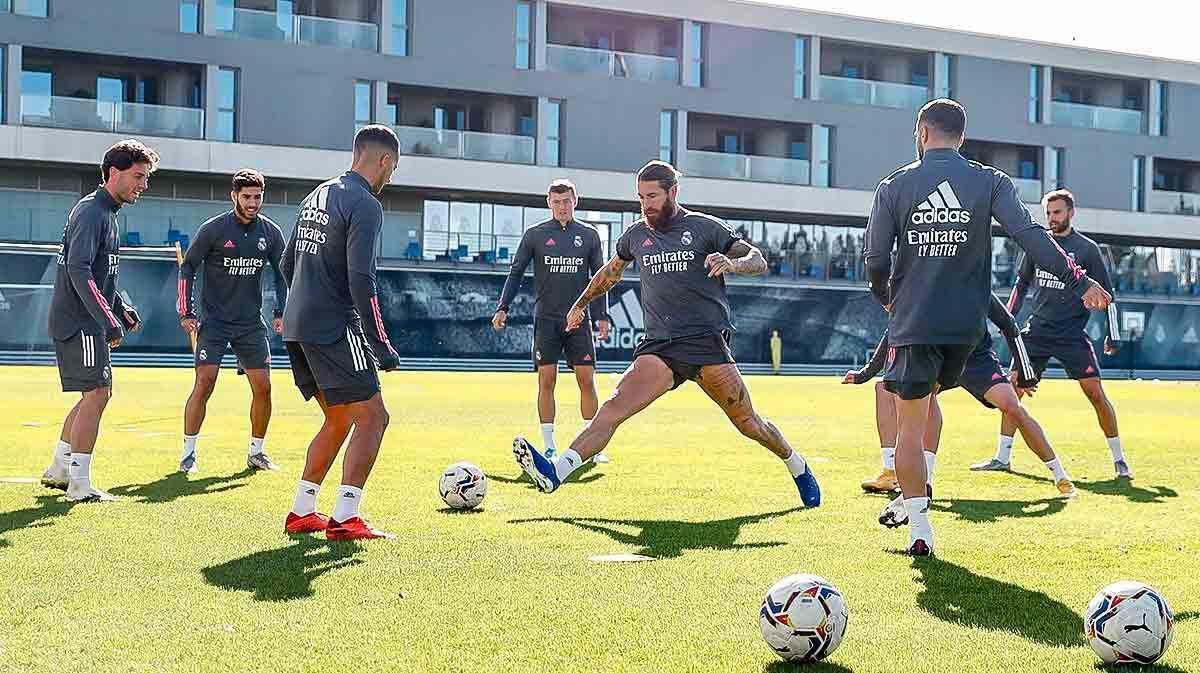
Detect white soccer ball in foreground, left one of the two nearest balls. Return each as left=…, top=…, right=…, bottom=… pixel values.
left=758, top=575, right=850, bottom=661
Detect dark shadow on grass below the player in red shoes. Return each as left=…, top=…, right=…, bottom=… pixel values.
left=200, top=535, right=362, bottom=601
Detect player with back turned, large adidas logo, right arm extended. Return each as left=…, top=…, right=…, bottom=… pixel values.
left=865, top=98, right=1112, bottom=555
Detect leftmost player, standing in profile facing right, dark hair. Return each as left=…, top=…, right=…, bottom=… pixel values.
left=42, top=139, right=158, bottom=503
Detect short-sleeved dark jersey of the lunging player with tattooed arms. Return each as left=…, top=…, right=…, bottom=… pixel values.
left=617, top=206, right=742, bottom=339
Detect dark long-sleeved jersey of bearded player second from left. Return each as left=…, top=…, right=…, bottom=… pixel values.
left=175, top=210, right=287, bottom=337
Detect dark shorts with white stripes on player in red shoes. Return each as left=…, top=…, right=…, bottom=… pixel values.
left=287, top=325, right=379, bottom=405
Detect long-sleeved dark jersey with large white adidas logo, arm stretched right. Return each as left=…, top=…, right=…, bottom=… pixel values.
left=865, top=149, right=1087, bottom=345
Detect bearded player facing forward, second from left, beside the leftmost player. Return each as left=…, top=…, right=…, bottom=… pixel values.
left=176, top=168, right=287, bottom=473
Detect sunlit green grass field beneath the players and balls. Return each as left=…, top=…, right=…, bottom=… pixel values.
left=0, top=367, right=1200, bottom=673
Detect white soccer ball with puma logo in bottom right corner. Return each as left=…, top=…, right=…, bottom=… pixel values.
left=1084, top=581, right=1175, bottom=663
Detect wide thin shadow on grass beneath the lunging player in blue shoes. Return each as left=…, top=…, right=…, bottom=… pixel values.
left=509, top=507, right=803, bottom=559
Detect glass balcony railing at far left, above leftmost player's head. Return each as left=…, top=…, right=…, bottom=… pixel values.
left=20, top=94, right=204, bottom=139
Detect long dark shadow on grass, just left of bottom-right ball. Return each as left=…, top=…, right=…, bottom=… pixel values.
left=913, top=557, right=1086, bottom=648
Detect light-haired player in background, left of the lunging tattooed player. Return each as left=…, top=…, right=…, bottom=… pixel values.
left=492, top=180, right=610, bottom=463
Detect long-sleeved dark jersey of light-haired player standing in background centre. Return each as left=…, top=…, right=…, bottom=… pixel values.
left=497, top=220, right=608, bottom=320
